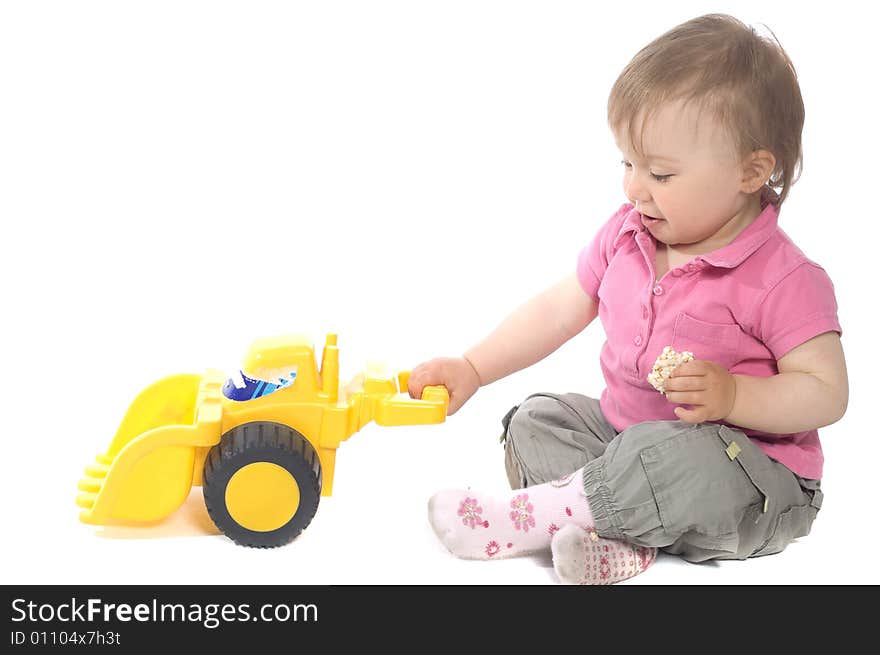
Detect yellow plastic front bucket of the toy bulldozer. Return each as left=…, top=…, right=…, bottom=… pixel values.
left=76, top=371, right=223, bottom=525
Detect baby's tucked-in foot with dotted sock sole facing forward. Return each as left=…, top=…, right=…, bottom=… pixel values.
left=550, top=525, right=657, bottom=585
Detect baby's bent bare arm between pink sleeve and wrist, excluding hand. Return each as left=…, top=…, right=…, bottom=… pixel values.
left=725, top=332, right=849, bottom=434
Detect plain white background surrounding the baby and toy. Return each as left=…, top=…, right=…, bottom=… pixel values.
left=0, top=0, right=880, bottom=584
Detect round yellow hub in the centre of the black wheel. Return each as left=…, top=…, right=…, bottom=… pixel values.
left=226, top=462, right=299, bottom=532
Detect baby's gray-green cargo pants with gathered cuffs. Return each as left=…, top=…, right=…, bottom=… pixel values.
left=502, top=393, right=822, bottom=562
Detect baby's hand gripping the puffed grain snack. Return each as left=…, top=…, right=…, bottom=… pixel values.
left=666, top=359, right=736, bottom=423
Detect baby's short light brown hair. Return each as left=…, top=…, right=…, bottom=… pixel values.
left=608, top=14, right=804, bottom=205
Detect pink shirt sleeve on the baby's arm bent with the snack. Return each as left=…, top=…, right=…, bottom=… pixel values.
left=753, top=261, right=843, bottom=360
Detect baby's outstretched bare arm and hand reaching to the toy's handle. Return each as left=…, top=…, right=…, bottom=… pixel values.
left=409, top=274, right=599, bottom=414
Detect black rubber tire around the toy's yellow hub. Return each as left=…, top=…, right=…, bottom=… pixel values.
left=202, top=421, right=321, bottom=548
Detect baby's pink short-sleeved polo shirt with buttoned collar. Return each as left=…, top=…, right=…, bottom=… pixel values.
left=577, top=197, right=841, bottom=479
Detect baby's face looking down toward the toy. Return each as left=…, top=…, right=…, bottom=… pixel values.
left=614, top=101, right=755, bottom=254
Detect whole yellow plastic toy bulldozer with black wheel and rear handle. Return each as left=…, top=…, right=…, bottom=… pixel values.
left=77, top=334, right=449, bottom=548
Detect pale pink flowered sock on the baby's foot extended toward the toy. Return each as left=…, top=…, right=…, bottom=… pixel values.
left=428, top=469, right=593, bottom=559
